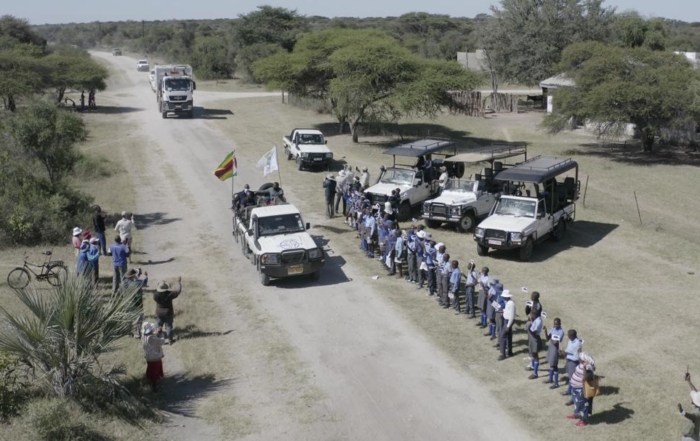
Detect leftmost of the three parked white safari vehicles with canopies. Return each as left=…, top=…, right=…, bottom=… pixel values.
left=365, top=139, right=464, bottom=222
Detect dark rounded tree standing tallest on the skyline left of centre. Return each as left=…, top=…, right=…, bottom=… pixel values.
left=234, top=5, right=307, bottom=52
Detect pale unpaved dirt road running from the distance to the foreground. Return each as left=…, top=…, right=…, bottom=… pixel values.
left=94, top=53, right=528, bottom=440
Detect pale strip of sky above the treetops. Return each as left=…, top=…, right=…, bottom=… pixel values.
left=6, top=0, right=700, bottom=24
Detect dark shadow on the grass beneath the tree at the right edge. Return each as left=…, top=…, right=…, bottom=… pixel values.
left=563, top=142, right=700, bottom=167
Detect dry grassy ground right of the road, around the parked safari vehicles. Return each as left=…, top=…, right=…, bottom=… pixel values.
left=207, top=98, right=700, bottom=440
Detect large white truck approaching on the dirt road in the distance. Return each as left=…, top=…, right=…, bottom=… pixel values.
left=151, top=64, right=197, bottom=118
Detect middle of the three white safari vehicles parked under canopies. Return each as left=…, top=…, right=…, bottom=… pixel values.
left=421, top=145, right=527, bottom=233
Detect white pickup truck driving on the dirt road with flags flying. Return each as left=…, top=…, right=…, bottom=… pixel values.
left=233, top=195, right=325, bottom=286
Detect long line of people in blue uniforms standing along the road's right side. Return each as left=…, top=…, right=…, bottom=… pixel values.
left=338, top=199, right=599, bottom=426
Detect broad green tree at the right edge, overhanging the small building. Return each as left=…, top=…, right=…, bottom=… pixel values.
left=544, top=42, right=700, bottom=152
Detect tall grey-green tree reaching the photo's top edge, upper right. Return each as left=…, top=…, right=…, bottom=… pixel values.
left=480, top=0, right=614, bottom=85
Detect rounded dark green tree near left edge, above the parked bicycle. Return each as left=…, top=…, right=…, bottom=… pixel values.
left=8, top=101, right=87, bottom=186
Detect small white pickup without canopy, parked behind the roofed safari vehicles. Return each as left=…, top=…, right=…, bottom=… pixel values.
left=282, top=129, right=333, bottom=171
